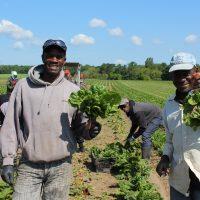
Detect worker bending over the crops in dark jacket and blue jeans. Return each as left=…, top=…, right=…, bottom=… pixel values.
left=119, top=99, right=162, bottom=159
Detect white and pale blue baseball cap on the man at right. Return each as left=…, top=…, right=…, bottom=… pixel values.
left=169, top=52, right=196, bottom=72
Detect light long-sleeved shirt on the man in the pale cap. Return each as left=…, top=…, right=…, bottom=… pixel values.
left=163, top=95, right=200, bottom=196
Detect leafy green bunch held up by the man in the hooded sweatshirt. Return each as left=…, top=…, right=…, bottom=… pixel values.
left=69, top=85, right=121, bottom=119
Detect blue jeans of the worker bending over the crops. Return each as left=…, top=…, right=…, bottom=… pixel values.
left=142, top=117, right=163, bottom=147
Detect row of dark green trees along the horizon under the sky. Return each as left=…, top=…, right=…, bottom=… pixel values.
left=0, top=57, right=177, bottom=80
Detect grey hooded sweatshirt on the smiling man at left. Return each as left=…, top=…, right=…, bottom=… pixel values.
left=0, top=65, right=82, bottom=165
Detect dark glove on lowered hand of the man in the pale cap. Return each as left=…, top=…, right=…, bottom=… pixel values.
left=156, top=155, right=170, bottom=176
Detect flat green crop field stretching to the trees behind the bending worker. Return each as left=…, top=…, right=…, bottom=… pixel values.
left=86, top=79, right=175, bottom=107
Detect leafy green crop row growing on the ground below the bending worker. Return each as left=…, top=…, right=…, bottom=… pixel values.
left=91, top=141, right=162, bottom=200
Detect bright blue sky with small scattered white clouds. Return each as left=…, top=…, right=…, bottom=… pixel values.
left=0, top=0, right=200, bottom=65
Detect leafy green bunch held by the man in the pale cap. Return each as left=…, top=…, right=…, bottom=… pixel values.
left=183, top=91, right=200, bottom=130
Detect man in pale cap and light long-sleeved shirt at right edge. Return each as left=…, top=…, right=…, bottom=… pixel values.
left=156, top=52, right=200, bottom=200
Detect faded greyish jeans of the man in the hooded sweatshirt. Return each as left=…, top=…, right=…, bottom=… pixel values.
left=13, top=159, right=72, bottom=200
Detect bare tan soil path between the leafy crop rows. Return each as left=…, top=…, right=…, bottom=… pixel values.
left=70, top=115, right=169, bottom=200
